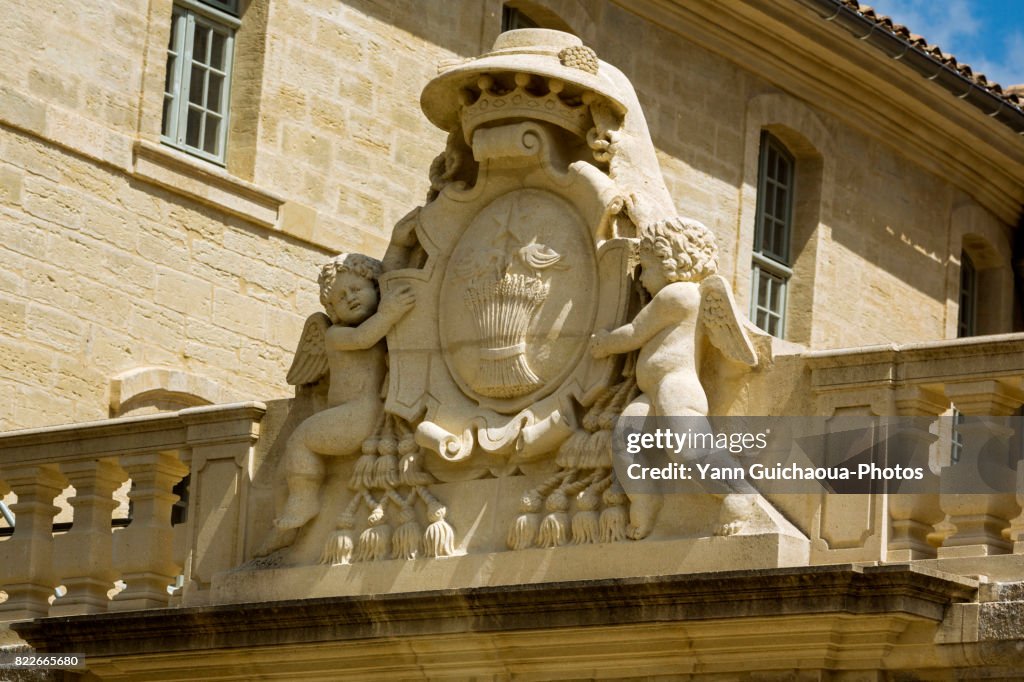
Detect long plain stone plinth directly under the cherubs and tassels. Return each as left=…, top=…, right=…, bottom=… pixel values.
left=209, top=528, right=809, bottom=606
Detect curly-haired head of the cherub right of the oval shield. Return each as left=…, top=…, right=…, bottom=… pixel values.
left=640, top=217, right=718, bottom=294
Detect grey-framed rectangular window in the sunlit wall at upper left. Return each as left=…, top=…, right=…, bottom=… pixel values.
left=161, top=0, right=239, bottom=164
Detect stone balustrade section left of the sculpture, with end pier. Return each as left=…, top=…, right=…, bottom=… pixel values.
left=0, top=402, right=265, bottom=621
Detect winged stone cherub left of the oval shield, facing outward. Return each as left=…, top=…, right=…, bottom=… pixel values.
left=257, top=253, right=415, bottom=555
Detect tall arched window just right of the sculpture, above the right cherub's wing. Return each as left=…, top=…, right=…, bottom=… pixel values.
left=751, top=132, right=795, bottom=338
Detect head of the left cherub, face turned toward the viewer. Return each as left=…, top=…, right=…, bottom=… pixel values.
left=318, top=253, right=381, bottom=327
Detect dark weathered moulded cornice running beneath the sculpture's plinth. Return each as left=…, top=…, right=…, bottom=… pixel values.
left=13, top=564, right=978, bottom=657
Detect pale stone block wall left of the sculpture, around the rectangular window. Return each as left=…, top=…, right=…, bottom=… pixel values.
left=0, top=0, right=478, bottom=430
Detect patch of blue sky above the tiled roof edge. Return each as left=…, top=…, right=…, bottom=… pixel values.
left=861, top=0, right=1024, bottom=87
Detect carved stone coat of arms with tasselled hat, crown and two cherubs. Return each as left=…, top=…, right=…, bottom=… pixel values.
left=263, top=29, right=766, bottom=563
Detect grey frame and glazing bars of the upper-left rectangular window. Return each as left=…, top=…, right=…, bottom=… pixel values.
left=160, top=0, right=241, bottom=166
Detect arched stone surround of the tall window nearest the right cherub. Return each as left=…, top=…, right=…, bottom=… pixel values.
left=732, top=92, right=836, bottom=345
